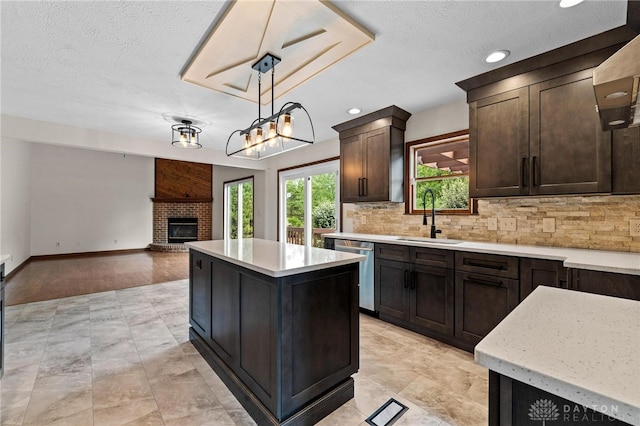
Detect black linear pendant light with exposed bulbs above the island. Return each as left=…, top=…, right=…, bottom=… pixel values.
left=226, top=53, right=315, bottom=160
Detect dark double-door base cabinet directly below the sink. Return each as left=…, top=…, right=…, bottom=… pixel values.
left=375, top=246, right=454, bottom=336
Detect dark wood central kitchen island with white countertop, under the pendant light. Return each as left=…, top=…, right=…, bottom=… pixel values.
left=186, top=238, right=364, bottom=425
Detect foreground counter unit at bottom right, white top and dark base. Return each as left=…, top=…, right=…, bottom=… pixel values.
left=475, top=286, right=640, bottom=425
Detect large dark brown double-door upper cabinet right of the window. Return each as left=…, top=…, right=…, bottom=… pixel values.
left=457, top=27, right=638, bottom=197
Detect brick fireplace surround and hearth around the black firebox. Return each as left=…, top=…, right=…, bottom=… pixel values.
left=150, top=200, right=212, bottom=252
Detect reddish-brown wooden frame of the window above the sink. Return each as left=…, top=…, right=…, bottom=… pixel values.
left=404, top=129, right=476, bottom=215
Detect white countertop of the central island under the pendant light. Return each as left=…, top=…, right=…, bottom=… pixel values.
left=185, top=238, right=365, bottom=277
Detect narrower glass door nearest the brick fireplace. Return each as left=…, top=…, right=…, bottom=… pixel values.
left=224, top=177, right=253, bottom=239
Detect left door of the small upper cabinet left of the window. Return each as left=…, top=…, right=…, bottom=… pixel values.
left=340, top=135, right=363, bottom=203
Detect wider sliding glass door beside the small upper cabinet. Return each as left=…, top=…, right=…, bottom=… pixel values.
left=278, top=160, right=340, bottom=247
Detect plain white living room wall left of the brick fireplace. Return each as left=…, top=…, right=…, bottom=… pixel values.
left=30, top=144, right=154, bottom=256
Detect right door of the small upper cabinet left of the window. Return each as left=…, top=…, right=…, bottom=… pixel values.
left=362, top=127, right=390, bottom=201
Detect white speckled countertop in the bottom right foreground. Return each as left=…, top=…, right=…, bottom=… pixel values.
left=475, top=286, right=640, bottom=425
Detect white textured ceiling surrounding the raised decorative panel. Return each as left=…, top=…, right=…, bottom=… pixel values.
left=0, top=0, right=626, bottom=161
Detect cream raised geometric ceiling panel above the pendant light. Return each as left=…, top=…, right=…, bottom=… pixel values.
left=181, top=0, right=375, bottom=104
